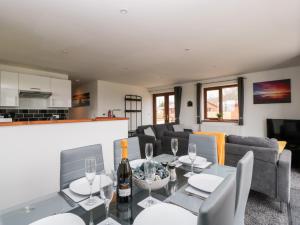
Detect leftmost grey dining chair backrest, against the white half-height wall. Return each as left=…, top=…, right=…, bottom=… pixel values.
left=60, top=144, right=104, bottom=190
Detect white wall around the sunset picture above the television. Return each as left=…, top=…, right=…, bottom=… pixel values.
left=242, top=67, right=300, bottom=136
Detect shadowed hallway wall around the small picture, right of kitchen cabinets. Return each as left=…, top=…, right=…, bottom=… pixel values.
left=69, top=81, right=101, bottom=119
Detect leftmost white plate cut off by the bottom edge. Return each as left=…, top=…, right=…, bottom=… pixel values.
left=29, top=213, right=85, bottom=225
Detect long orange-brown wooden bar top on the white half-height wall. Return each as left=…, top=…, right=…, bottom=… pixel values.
left=0, top=117, right=128, bottom=127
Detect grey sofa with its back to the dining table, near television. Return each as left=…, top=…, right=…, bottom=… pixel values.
left=225, top=135, right=291, bottom=207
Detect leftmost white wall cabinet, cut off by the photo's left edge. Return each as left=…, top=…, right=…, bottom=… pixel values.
left=0, top=71, right=19, bottom=107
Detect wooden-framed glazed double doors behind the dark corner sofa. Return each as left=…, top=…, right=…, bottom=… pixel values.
left=153, top=92, right=175, bottom=124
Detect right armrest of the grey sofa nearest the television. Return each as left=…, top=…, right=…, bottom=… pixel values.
left=277, top=150, right=292, bottom=203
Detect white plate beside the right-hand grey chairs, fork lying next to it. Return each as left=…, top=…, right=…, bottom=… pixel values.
left=188, top=173, right=224, bottom=193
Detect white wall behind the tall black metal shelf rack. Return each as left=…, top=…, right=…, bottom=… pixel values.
left=98, top=80, right=153, bottom=124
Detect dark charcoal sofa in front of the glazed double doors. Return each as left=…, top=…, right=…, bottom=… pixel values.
left=136, top=123, right=192, bottom=157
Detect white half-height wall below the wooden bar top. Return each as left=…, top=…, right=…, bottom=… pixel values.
left=0, top=120, right=128, bottom=211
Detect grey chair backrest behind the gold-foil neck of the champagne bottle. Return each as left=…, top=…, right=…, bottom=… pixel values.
left=114, top=137, right=141, bottom=170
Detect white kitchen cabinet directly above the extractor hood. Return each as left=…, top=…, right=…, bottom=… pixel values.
left=19, top=74, right=51, bottom=92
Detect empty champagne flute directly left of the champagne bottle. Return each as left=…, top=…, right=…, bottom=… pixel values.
left=100, top=172, right=115, bottom=225
